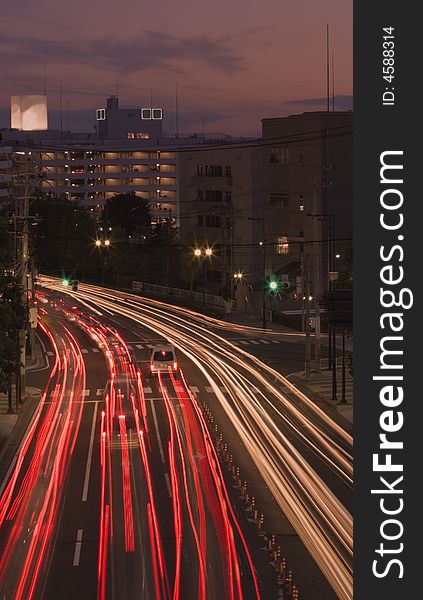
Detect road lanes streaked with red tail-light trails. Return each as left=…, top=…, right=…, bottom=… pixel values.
left=0, top=292, right=277, bottom=600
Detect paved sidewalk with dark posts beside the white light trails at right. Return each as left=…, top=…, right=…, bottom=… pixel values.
left=288, top=368, right=354, bottom=429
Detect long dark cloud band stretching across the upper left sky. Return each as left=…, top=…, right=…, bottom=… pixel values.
left=0, top=31, right=243, bottom=75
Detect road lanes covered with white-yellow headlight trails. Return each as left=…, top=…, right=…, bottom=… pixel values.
left=37, top=280, right=352, bottom=598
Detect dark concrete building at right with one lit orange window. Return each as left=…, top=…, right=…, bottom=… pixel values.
left=179, top=112, right=352, bottom=311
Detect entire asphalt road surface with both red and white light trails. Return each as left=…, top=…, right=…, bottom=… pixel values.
left=0, top=280, right=352, bottom=600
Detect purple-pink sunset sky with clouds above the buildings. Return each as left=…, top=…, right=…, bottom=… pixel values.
left=0, top=0, right=352, bottom=135
